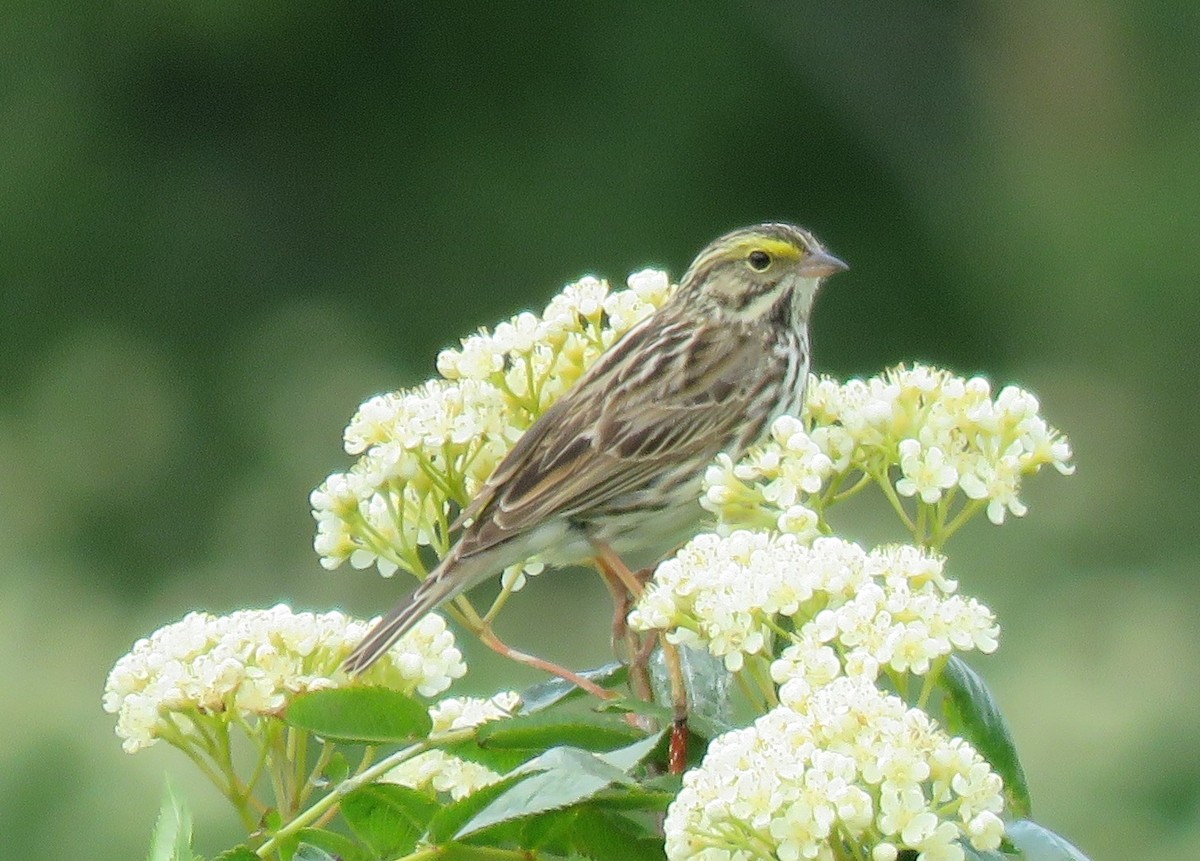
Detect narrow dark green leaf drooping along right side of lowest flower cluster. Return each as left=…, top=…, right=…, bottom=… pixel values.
left=937, top=655, right=1032, bottom=817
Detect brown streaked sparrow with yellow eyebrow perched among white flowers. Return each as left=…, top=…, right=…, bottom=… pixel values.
left=344, top=222, right=848, bottom=673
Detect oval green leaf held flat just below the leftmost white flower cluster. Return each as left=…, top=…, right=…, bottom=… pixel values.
left=283, top=687, right=433, bottom=745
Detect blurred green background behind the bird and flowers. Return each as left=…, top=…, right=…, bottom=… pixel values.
left=0, top=0, right=1200, bottom=861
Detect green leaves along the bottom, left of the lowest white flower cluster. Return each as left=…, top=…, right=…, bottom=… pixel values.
left=138, top=688, right=678, bottom=861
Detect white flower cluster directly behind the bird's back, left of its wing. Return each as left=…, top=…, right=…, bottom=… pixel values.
left=310, top=270, right=673, bottom=585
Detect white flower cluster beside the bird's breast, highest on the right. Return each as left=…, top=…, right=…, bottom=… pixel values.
left=702, top=365, right=1074, bottom=536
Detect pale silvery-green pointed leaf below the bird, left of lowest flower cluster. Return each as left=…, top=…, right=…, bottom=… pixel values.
left=455, top=733, right=661, bottom=838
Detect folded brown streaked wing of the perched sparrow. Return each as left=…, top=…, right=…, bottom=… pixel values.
left=451, top=329, right=769, bottom=554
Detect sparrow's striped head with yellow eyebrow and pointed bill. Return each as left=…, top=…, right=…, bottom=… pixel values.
left=677, top=223, right=847, bottom=325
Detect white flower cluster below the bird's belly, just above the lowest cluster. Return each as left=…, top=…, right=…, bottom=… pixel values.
left=629, top=530, right=1000, bottom=681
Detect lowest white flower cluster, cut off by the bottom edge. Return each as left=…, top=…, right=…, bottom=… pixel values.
left=665, top=678, right=1004, bottom=861
